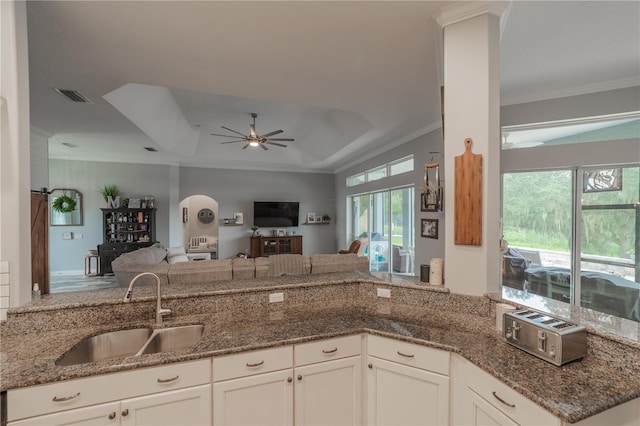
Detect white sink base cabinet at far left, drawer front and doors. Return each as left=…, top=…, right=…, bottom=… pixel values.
left=7, top=359, right=211, bottom=426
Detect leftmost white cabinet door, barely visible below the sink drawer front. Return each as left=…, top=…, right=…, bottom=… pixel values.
left=8, top=402, right=120, bottom=426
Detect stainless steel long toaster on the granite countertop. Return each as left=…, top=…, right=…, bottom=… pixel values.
left=503, top=309, right=587, bottom=366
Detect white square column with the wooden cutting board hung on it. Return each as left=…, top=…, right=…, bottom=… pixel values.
left=436, top=2, right=504, bottom=295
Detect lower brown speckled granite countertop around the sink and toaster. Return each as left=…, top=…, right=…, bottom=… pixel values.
left=0, top=272, right=640, bottom=423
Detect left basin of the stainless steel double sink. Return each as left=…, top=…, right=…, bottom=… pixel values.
left=56, top=328, right=153, bottom=365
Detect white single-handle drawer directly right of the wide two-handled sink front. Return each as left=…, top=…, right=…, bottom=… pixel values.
left=213, top=346, right=293, bottom=382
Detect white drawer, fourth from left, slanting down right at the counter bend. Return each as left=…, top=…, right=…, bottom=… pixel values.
left=367, top=335, right=449, bottom=376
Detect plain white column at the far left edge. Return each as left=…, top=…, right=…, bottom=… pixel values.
left=0, top=1, right=31, bottom=306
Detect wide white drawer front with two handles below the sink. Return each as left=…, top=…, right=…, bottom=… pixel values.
left=7, top=359, right=211, bottom=421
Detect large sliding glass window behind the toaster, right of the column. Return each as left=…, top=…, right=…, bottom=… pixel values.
left=502, top=161, right=640, bottom=322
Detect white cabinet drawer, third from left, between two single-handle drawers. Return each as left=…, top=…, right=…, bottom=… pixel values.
left=293, top=335, right=362, bottom=367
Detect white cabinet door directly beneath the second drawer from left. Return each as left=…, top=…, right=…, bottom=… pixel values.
left=213, top=369, right=293, bottom=426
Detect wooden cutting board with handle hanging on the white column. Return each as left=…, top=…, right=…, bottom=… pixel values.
left=454, top=138, right=482, bottom=246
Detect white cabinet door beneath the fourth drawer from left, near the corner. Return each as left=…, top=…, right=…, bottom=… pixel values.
left=367, top=356, right=449, bottom=426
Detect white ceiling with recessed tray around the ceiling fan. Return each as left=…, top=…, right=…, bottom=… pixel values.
left=27, top=1, right=640, bottom=172
